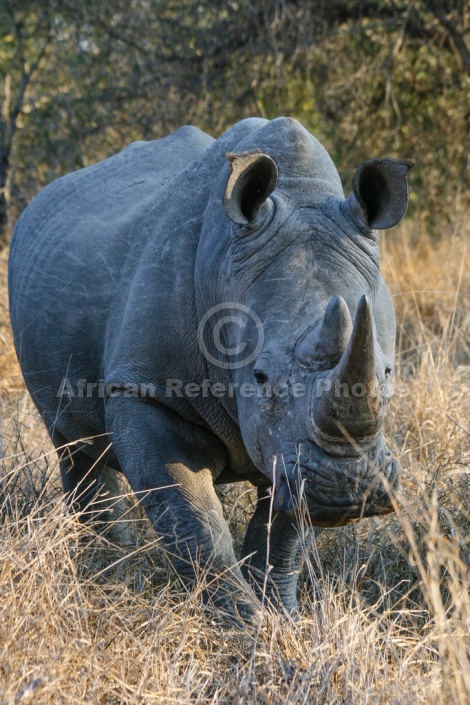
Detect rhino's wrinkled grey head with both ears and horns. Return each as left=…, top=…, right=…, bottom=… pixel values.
left=197, top=120, right=411, bottom=526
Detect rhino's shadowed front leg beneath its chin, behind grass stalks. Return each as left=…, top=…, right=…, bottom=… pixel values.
left=242, top=487, right=313, bottom=612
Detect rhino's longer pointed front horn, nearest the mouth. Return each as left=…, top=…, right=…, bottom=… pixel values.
left=313, top=296, right=384, bottom=450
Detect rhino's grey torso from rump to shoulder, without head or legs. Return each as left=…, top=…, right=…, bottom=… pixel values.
left=9, top=119, right=266, bottom=452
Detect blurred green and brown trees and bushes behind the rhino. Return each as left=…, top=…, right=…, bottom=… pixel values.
left=0, top=0, right=470, bottom=236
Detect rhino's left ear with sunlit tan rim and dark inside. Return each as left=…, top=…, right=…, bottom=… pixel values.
left=224, top=152, right=278, bottom=225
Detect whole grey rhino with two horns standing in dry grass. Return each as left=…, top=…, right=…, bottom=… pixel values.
left=9, top=118, right=409, bottom=615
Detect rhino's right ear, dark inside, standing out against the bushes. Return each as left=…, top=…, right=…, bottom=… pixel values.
left=351, top=159, right=413, bottom=230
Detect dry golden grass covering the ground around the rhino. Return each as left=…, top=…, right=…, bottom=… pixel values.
left=0, top=216, right=470, bottom=705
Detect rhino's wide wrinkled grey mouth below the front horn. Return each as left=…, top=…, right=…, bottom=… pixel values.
left=274, top=442, right=401, bottom=527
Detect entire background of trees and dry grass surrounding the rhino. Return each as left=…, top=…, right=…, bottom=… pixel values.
left=0, top=0, right=470, bottom=705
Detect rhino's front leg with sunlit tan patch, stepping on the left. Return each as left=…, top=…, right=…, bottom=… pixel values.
left=106, top=396, right=258, bottom=618
